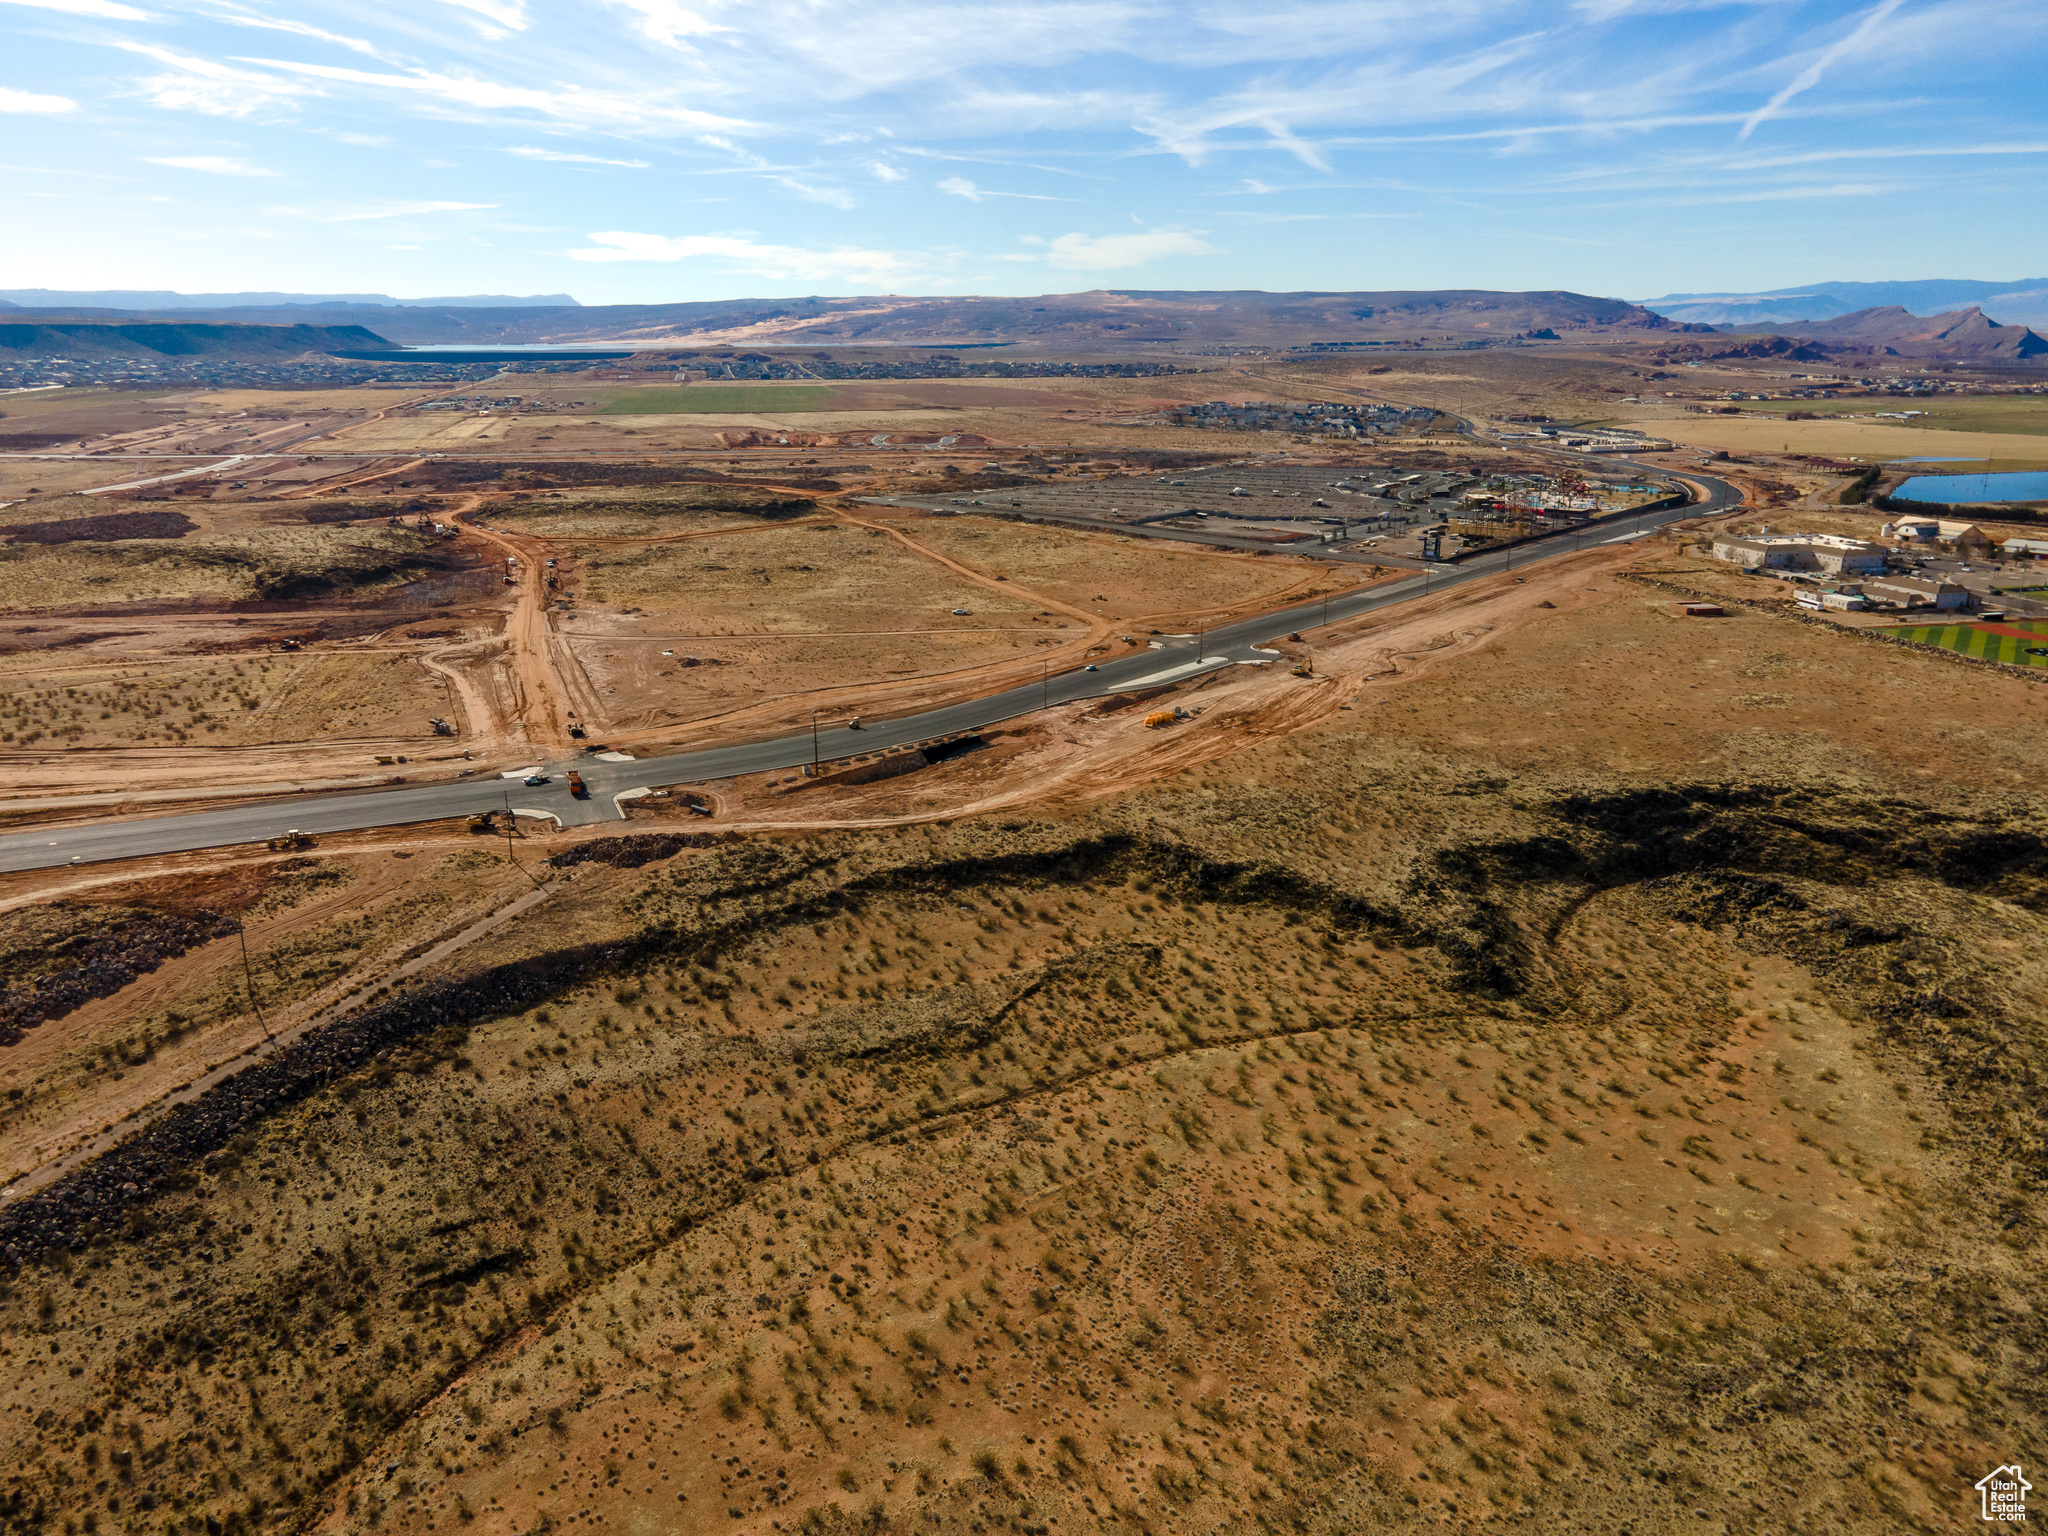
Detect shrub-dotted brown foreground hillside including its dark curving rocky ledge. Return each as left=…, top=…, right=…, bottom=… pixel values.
left=0, top=696, right=2048, bottom=1532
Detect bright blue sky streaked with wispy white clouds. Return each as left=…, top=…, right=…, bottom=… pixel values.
left=0, top=0, right=2048, bottom=303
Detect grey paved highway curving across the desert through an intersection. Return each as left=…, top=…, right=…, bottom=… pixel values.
left=0, top=461, right=1741, bottom=872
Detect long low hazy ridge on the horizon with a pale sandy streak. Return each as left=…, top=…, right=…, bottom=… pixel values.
left=0, top=289, right=1686, bottom=352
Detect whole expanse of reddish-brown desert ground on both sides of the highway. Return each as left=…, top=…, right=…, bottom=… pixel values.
left=0, top=342, right=2048, bottom=1536
